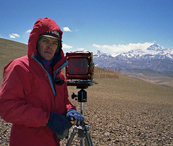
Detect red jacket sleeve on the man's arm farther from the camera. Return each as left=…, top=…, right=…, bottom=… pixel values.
left=0, top=61, right=49, bottom=127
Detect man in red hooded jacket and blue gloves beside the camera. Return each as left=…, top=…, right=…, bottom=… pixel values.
left=0, top=18, right=84, bottom=146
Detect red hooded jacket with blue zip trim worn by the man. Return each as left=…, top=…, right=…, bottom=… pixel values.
left=0, top=18, right=75, bottom=146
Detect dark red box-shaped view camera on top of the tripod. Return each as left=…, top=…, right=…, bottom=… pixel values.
left=66, top=52, right=96, bottom=87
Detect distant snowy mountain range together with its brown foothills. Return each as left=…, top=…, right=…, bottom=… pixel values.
left=93, top=44, right=173, bottom=88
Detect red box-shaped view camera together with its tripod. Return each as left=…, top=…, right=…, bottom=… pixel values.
left=66, top=52, right=97, bottom=146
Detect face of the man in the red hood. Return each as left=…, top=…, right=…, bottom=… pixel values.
left=38, top=36, right=58, bottom=61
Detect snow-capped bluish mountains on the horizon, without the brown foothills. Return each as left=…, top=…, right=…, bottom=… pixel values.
left=93, top=44, right=173, bottom=71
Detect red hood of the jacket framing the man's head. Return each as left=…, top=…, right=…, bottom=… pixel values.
left=28, top=18, right=64, bottom=57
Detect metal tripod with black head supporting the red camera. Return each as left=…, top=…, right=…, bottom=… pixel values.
left=66, top=86, right=93, bottom=146
